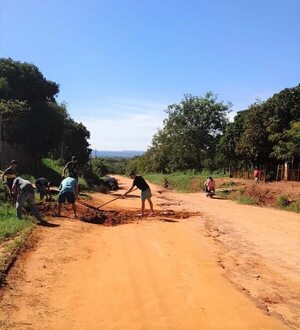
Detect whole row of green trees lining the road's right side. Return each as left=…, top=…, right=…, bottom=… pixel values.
left=128, top=85, right=300, bottom=178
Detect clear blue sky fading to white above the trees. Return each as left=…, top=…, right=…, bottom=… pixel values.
left=0, top=0, right=300, bottom=150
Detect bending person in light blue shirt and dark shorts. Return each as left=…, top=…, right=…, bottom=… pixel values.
left=58, top=176, right=78, bottom=218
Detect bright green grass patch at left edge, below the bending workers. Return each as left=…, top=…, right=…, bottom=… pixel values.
left=0, top=204, right=34, bottom=243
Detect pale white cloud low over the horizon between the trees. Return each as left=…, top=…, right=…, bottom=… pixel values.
left=75, top=100, right=166, bottom=150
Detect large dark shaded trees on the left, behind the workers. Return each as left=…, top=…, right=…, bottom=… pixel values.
left=0, top=58, right=90, bottom=164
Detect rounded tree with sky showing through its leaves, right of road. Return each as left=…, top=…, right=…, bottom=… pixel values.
left=137, top=93, right=230, bottom=173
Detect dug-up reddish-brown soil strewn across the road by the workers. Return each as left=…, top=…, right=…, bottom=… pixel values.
left=37, top=202, right=200, bottom=226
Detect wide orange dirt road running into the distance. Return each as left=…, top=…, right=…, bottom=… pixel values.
left=0, top=177, right=300, bottom=330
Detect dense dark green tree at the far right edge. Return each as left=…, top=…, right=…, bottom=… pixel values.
left=236, top=85, right=300, bottom=163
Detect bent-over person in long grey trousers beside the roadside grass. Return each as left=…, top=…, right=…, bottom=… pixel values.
left=12, top=176, right=46, bottom=223
